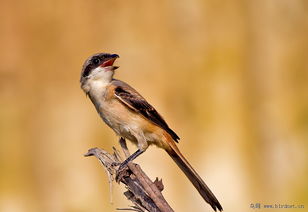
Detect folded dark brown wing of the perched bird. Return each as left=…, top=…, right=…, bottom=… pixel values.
left=113, top=80, right=180, bottom=142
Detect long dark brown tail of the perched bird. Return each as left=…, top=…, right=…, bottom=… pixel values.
left=166, top=142, right=223, bottom=211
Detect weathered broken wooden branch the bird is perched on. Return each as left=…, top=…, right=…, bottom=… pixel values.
left=85, top=139, right=173, bottom=212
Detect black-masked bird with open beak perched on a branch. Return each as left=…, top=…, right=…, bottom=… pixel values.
left=80, top=53, right=222, bottom=211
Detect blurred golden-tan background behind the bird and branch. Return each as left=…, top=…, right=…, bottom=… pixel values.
left=0, top=0, right=308, bottom=212
